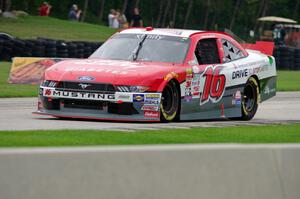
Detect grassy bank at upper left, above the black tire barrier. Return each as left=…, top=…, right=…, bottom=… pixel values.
left=0, top=16, right=116, bottom=41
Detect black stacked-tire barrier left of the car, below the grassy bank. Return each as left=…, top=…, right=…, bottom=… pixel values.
left=0, top=33, right=102, bottom=61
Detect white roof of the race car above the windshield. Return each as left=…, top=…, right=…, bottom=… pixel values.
left=120, top=28, right=204, bottom=37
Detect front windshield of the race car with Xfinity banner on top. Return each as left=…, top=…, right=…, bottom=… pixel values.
left=90, top=34, right=190, bottom=63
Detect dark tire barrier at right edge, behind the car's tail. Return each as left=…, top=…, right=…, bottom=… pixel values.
left=273, top=46, right=300, bottom=70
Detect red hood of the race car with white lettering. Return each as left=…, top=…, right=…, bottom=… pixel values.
left=45, top=59, right=183, bottom=86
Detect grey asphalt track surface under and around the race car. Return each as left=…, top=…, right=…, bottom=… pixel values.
left=0, top=92, right=300, bottom=131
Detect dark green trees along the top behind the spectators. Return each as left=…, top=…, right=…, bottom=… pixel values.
left=0, top=0, right=300, bottom=39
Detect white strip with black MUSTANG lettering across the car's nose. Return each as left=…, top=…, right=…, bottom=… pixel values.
left=44, top=89, right=115, bottom=101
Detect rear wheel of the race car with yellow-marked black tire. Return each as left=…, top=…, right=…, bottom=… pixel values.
left=241, top=77, right=259, bottom=120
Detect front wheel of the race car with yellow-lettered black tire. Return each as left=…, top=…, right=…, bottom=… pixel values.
left=160, top=81, right=180, bottom=122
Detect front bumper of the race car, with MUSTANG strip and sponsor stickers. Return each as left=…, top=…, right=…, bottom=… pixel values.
left=34, top=87, right=161, bottom=121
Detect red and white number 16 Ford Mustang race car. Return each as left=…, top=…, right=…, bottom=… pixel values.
left=35, top=27, right=276, bottom=122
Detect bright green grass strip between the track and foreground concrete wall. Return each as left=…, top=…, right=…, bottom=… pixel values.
left=0, top=124, right=300, bottom=147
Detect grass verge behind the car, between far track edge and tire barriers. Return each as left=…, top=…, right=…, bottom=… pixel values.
left=0, top=62, right=300, bottom=97
